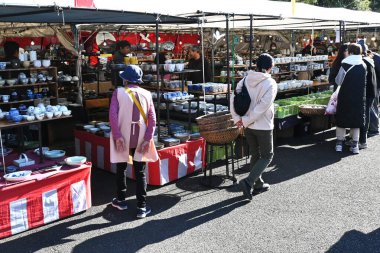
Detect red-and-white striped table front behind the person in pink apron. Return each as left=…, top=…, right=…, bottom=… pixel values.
left=74, top=130, right=206, bottom=185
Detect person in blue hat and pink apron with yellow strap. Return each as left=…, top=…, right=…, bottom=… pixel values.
left=109, top=65, right=158, bottom=218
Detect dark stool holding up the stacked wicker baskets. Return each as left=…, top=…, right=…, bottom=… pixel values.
left=202, top=142, right=237, bottom=187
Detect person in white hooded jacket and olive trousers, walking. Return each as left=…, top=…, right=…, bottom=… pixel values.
left=230, top=54, right=277, bottom=200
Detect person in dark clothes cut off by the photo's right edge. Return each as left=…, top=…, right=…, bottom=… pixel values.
left=368, top=53, right=380, bottom=137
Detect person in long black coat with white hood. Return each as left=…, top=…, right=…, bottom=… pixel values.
left=335, top=43, right=367, bottom=154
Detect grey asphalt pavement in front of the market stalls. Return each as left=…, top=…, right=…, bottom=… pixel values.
left=0, top=131, right=380, bottom=253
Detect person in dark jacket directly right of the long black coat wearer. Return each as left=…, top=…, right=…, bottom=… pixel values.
left=359, top=42, right=377, bottom=149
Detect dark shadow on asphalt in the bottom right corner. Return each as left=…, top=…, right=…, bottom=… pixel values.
left=326, top=228, right=380, bottom=253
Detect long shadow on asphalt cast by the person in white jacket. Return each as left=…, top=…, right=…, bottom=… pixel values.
left=72, top=197, right=249, bottom=253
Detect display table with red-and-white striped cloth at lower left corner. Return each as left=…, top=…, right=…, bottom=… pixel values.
left=0, top=153, right=91, bottom=238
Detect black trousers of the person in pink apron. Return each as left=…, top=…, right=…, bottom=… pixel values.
left=116, top=149, right=147, bottom=208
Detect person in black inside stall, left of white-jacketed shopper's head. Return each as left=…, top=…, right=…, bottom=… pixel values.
left=187, top=46, right=211, bottom=83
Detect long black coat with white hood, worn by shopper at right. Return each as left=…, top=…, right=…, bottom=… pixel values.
left=335, top=55, right=367, bottom=128
